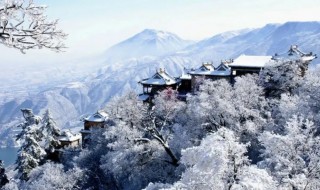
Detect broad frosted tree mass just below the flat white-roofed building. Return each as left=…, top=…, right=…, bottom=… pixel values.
left=188, top=75, right=268, bottom=134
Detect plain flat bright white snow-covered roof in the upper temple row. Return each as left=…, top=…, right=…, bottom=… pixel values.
left=229, top=55, right=272, bottom=68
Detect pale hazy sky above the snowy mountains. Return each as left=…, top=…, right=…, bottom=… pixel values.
left=0, top=0, right=320, bottom=66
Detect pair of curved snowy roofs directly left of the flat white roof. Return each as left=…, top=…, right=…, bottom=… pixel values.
left=189, top=63, right=231, bottom=76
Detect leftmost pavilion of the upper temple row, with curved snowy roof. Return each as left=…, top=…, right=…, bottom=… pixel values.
left=139, top=69, right=180, bottom=101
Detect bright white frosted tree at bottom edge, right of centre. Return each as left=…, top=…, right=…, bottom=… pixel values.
left=146, top=128, right=276, bottom=190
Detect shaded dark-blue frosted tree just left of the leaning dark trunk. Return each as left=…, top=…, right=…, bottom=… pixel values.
left=95, top=123, right=176, bottom=189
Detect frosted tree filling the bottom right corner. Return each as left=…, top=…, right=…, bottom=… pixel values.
left=260, top=116, right=320, bottom=189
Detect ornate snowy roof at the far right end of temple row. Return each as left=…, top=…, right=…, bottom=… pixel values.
left=272, top=45, right=317, bottom=62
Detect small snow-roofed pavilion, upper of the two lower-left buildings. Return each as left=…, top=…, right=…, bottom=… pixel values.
left=80, top=110, right=109, bottom=145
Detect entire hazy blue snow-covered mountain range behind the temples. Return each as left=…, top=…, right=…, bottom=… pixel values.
left=0, top=22, right=320, bottom=145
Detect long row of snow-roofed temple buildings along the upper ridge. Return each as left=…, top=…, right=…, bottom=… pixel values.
left=139, top=45, right=316, bottom=102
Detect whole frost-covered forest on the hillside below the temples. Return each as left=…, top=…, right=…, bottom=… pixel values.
left=2, top=61, right=320, bottom=190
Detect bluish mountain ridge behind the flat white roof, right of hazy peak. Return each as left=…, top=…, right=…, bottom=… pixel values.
left=183, top=22, right=320, bottom=61
